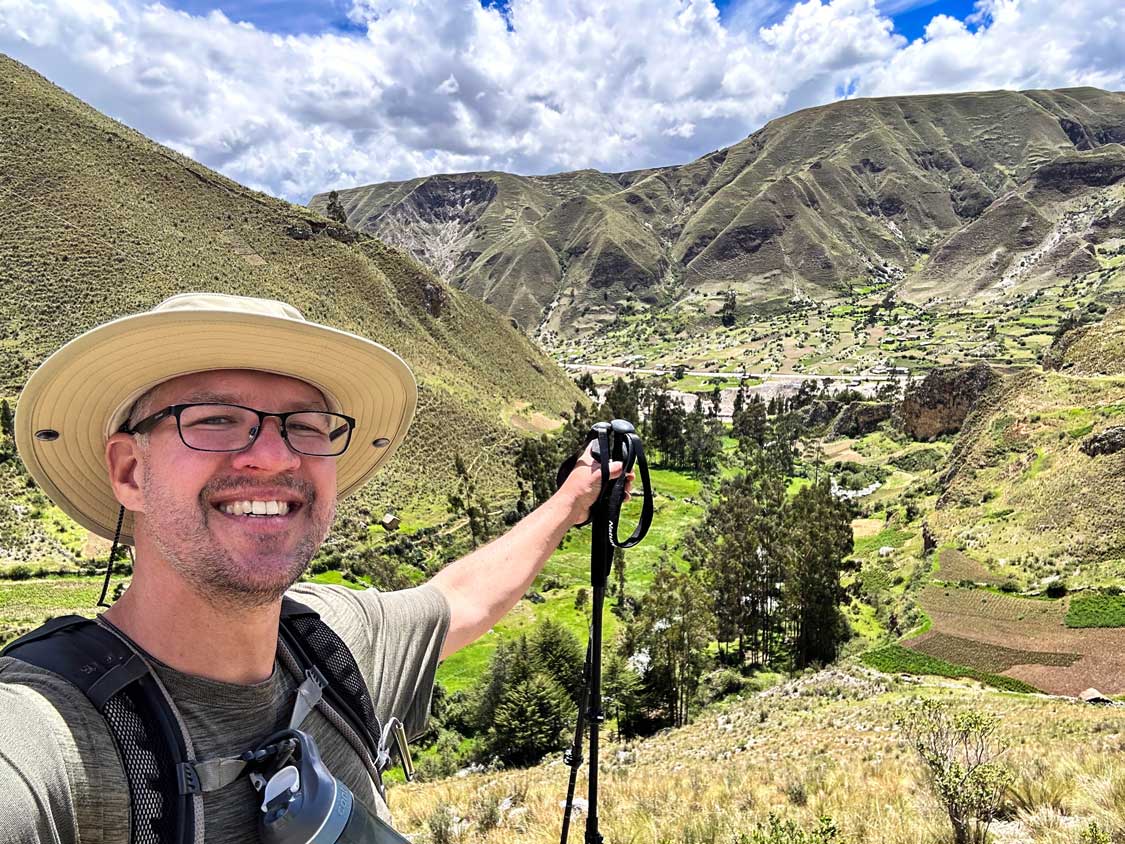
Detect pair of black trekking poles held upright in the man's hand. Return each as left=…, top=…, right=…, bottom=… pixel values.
left=558, top=419, right=653, bottom=844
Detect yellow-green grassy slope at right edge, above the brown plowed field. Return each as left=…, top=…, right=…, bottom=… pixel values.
left=930, top=308, right=1125, bottom=586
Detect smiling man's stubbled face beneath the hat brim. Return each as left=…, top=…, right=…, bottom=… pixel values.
left=129, top=369, right=336, bottom=607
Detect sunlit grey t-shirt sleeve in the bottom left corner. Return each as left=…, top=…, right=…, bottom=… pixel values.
left=0, top=658, right=128, bottom=844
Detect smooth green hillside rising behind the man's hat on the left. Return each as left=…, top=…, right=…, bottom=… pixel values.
left=0, top=52, right=581, bottom=564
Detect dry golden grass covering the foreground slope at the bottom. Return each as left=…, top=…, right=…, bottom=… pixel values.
left=390, top=670, right=1125, bottom=844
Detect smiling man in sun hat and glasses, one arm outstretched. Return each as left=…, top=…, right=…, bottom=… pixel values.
left=0, top=294, right=621, bottom=844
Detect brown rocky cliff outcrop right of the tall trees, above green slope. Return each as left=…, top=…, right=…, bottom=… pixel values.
left=898, top=363, right=1000, bottom=440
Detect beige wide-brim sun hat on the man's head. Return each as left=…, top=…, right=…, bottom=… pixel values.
left=16, top=293, right=417, bottom=545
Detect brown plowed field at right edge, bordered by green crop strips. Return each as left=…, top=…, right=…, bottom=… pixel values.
left=902, top=586, right=1125, bottom=695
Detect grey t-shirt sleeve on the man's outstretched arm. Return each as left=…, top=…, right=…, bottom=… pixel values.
left=283, top=583, right=449, bottom=737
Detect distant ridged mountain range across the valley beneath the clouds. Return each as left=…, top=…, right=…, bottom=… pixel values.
left=311, top=88, right=1125, bottom=371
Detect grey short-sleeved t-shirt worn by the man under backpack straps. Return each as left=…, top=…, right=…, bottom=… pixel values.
left=0, top=583, right=449, bottom=844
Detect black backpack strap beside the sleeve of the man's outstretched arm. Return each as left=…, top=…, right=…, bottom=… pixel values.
left=279, top=596, right=385, bottom=784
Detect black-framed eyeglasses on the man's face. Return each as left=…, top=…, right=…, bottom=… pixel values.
left=122, top=403, right=356, bottom=457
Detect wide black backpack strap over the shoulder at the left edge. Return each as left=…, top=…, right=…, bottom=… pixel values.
left=0, top=616, right=201, bottom=844
